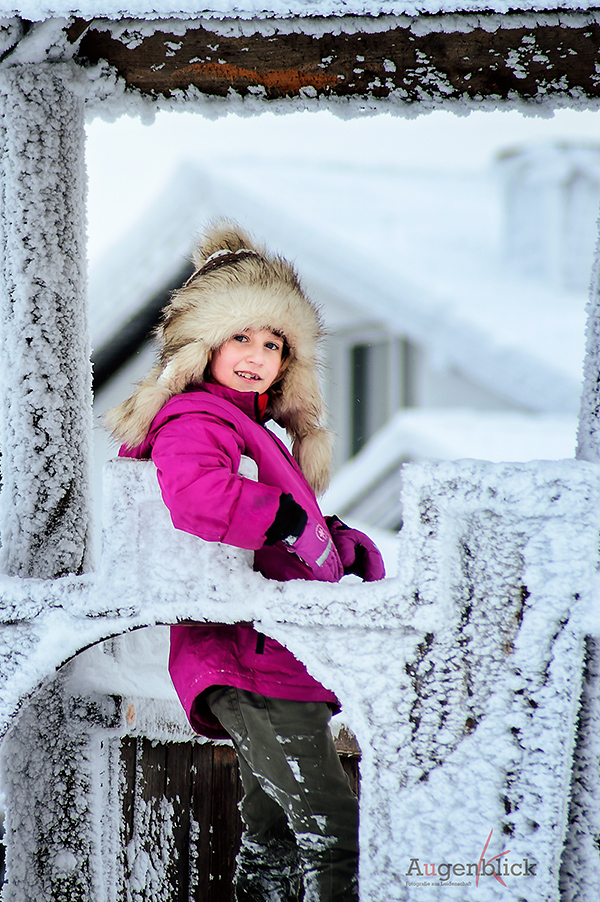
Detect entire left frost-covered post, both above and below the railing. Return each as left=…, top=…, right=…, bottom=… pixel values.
left=0, top=63, right=91, bottom=902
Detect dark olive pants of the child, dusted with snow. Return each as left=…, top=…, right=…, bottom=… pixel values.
left=205, top=686, right=358, bottom=902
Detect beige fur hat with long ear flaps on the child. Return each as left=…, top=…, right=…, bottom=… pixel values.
left=104, top=221, right=331, bottom=494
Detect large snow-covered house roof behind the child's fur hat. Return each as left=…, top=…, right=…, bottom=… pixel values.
left=90, top=159, right=587, bottom=413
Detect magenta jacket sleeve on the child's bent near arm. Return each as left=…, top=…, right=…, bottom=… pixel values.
left=152, top=412, right=281, bottom=550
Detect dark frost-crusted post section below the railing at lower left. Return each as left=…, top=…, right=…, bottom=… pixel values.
left=2, top=679, right=119, bottom=902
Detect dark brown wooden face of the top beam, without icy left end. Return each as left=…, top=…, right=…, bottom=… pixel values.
left=71, top=11, right=600, bottom=104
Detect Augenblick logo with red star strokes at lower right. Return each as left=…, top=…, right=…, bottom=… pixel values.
left=406, top=828, right=536, bottom=886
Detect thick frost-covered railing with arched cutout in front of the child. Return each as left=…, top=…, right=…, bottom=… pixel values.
left=0, top=460, right=600, bottom=902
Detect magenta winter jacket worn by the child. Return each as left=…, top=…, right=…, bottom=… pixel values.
left=119, top=383, right=340, bottom=738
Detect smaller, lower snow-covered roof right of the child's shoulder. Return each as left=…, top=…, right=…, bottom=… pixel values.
left=321, top=409, right=577, bottom=514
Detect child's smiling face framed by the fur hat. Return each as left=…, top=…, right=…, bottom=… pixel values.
left=210, top=329, right=283, bottom=394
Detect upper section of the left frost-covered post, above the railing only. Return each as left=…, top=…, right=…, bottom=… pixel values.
left=0, top=63, right=91, bottom=578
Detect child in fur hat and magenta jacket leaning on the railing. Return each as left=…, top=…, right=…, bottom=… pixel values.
left=107, top=223, right=385, bottom=902
